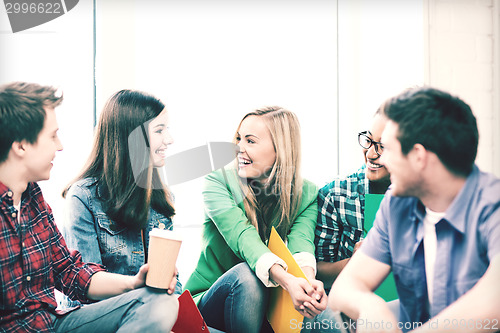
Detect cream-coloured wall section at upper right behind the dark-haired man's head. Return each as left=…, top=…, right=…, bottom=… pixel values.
left=425, top=0, right=500, bottom=176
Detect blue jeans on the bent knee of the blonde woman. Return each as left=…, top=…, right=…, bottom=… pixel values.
left=198, top=263, right=269, bottom=333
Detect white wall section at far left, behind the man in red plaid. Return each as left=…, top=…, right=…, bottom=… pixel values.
left=0, top=1, right=94, bottom=221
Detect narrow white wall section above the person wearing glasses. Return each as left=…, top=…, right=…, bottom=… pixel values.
left=332, top=0, right=424, bottom=175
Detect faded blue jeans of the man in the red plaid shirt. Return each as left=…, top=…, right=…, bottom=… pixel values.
left=52, top=287, right=179, bottom=333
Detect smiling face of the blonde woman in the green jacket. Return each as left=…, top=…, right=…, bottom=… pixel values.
left=236, top=116, right=276, bottom=181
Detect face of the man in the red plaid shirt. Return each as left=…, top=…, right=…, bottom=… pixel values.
left=23, top=108, right=63, bottom=182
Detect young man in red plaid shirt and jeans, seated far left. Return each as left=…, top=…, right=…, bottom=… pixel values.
left=0, top=82, right=178, bottom=332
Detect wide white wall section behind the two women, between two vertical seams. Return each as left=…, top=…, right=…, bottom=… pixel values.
left=97, top=0, right=338, bottom=282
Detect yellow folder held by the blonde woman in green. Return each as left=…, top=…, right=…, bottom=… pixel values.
left=267, top=227, right=307, bottom=333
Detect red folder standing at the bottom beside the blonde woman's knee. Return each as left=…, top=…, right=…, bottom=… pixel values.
left=172, top=290, right=208, bottom=333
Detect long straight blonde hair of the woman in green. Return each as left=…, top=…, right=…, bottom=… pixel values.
left=233, top=106, right=303, bottom=241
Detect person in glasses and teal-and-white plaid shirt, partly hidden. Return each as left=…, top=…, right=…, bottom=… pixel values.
left=315, top=104, right=390, bottom=289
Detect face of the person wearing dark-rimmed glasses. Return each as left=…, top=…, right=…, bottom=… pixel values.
left=363, top=114, right=389, bottom=182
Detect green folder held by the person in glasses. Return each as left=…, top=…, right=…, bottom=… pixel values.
left=364, top=194, right=398, bottom=302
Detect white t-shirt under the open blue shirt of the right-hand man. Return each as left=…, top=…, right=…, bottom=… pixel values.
left=424, top=208, right=444, bottom=304
